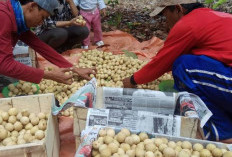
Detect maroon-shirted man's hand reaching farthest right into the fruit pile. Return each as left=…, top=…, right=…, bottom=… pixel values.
left=72, top=68, right=97, bottom=80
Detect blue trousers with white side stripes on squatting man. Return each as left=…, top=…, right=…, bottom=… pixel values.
left=172, top=55, right=232, bottom=141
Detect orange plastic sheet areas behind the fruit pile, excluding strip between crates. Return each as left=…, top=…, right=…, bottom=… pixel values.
left=37, top=30, right=163, bottom=69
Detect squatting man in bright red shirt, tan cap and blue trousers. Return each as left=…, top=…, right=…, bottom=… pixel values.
left=123, top=0, right=232, bottom=143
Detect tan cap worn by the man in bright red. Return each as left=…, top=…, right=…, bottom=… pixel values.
left=150, top=0, right=201, bottom=16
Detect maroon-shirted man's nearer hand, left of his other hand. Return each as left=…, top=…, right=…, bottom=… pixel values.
left=43, top=68, right=73, bottom=85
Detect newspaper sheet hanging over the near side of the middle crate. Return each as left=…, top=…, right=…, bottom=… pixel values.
left=86, top=108, right=181, bottom=136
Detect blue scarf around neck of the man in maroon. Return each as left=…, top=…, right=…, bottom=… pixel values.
left=11, top=0, right=29, bottom=34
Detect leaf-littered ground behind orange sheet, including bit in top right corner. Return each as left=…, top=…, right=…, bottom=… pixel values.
left=102, top=0, right=232, bottom=41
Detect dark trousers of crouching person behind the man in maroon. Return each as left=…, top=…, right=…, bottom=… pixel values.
left=38, top=26, right=89, bottom=53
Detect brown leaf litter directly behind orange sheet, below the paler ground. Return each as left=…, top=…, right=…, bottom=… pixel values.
left=102, top=9, right=167, bottom=41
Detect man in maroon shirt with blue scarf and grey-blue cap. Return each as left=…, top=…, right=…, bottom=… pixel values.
left=0, top=0, right=95, bottom=84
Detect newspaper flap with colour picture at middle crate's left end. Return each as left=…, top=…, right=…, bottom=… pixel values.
left=52, top=78, right=97, bottom=115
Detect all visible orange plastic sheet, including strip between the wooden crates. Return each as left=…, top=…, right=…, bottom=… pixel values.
left=37, top=30, right=163, bottom=157
